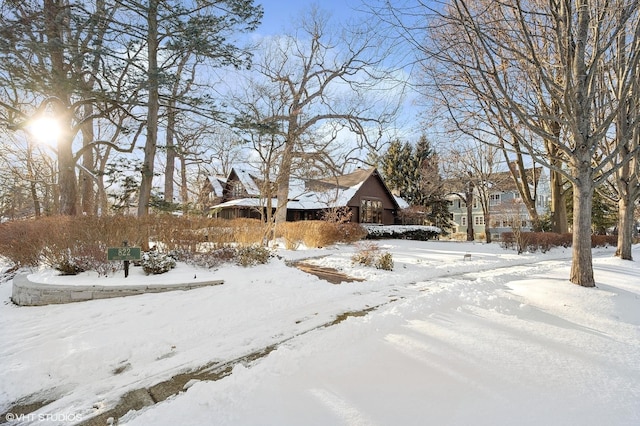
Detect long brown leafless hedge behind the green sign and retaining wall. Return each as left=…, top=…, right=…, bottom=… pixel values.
left=0, top=214, right=366, bottom=275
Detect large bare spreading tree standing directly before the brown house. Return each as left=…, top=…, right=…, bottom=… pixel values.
left=231, top=5, right=397, bottom=223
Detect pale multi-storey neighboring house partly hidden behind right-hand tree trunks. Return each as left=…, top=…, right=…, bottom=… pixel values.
left=447, top=168, right=551, bottom=240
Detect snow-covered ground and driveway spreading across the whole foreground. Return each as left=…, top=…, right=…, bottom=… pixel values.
left=0, top=240, right=640, bottom=426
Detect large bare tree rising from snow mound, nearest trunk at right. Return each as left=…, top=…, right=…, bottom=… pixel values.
left=382, top=0, right=640, bottom=287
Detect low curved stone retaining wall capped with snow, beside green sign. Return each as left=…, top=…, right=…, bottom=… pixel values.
left=11, top=274, right=224, bottom=306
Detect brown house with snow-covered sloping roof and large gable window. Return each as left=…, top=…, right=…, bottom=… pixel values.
left=205, top=168, right=406, bottom=225
